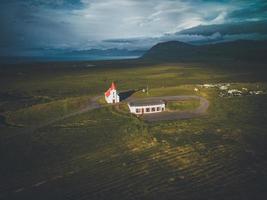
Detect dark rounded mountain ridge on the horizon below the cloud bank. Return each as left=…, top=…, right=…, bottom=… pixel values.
left=142, top=40, right=267, bottom=62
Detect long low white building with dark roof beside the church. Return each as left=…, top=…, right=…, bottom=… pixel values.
left=128, top=100, right=165, bottom=115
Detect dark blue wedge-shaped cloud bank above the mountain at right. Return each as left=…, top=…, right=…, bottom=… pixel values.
left=179, top=20, right=267, bottom=36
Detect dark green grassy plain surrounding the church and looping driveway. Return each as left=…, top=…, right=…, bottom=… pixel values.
left=0, top=62, right=267, bottom=200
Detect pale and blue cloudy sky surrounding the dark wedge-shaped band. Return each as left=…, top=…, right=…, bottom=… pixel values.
left=0, top=0, right=267, bottom=52
